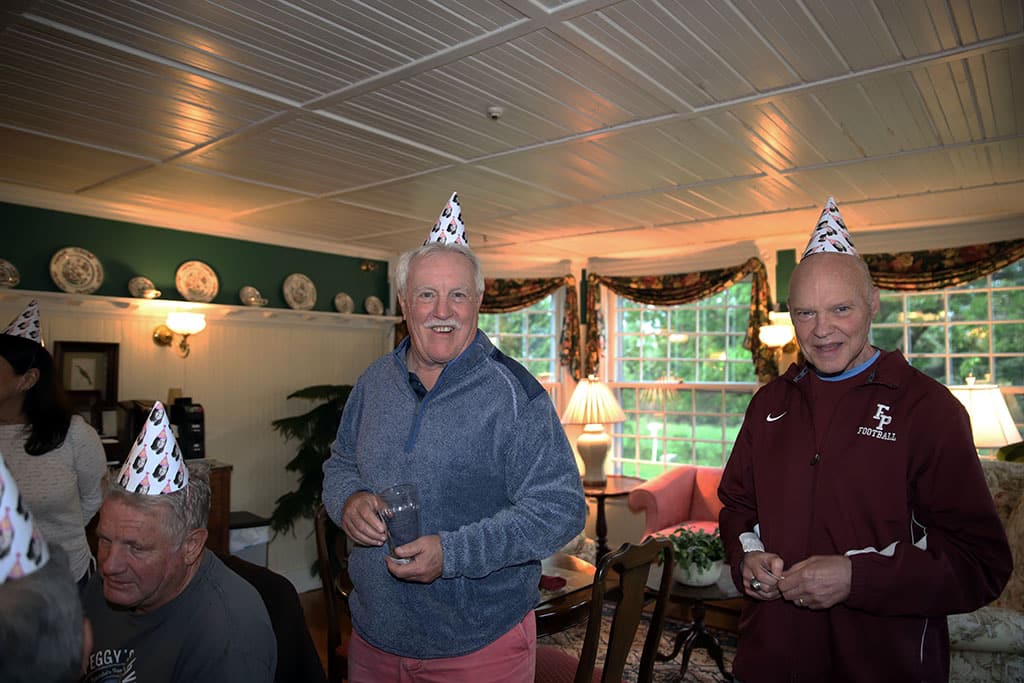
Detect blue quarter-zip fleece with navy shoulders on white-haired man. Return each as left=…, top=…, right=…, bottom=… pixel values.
left=324, top=330, right=586, bottom=658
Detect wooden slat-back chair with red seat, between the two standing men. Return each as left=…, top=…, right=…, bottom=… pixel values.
left=535, top=537, right=673, bottom=683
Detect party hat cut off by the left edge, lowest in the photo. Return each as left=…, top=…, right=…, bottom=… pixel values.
left=0, top=455, right=50, bottom=584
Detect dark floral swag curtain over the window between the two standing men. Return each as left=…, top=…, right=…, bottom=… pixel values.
left=584, top=258, right=778, bottom=381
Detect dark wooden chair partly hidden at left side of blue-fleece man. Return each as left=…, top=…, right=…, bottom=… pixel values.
left=313, top=505, right=352, bottom=683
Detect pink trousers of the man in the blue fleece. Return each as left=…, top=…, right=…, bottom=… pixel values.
left=348, top=611, right=537, bottom=683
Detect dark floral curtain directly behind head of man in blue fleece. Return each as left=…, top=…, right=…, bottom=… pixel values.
left=394, top=275, right=580, bottom=380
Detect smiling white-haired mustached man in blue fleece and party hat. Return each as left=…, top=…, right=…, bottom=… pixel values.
left=324, top=195, right=586, bottom=683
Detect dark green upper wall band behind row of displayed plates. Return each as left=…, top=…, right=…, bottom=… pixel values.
left=0, top=203, right=388, bottom=313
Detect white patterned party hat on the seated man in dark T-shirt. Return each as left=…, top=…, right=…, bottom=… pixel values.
left=118, top=400, right=188, bottom=496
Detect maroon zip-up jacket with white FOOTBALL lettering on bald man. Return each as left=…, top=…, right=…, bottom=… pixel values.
left=719, top=351, right=1013, bottom=683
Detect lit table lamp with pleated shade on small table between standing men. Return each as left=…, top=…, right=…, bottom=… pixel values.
left=562, top=375, right=626, bottom=486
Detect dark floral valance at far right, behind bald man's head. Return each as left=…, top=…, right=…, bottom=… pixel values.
left=864, top=240, right=1024, bottom=291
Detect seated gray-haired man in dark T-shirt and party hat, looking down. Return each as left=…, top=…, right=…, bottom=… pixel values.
left=83, top=402, right=276, bottom=683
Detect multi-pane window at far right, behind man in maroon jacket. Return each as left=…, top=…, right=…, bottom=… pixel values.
left=871, top=260, right=1024, bottom=427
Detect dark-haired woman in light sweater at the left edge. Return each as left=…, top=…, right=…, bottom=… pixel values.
left=0, top=303, right=106, bottom=582
